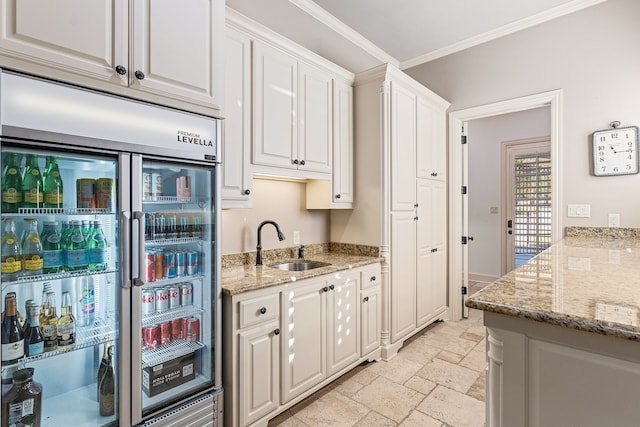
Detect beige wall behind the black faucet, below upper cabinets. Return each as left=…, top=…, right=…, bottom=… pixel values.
left=220, top=179, right=329, bottom=255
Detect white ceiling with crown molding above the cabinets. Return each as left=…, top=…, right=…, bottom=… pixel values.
left=226, top=0, right=606, bottom=73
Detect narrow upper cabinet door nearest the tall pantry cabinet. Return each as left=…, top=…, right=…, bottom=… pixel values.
left=332, top=80, right=353, bottom=204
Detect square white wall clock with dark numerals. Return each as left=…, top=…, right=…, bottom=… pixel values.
left=591, top=121, right=639, bottom=176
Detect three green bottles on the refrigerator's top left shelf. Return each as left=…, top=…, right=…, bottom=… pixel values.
left=2, top=152, right=64, bottom=213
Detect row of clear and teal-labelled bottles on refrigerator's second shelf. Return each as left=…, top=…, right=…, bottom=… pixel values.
left=2, top=218, right=108, bottom=282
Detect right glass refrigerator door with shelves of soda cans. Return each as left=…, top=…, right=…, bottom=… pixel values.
left=132, top=156, right=216, bottom=421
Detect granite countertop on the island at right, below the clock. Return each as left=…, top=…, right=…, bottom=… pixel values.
left=466, top=229, right=640, bottom=342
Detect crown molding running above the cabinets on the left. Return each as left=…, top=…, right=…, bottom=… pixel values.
left=289, top=0, right=400, bottom=67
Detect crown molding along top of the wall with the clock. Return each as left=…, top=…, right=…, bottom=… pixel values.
left=400, top=0, right=607, bottom=70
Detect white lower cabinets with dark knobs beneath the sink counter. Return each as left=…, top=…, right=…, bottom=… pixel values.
left=223, top=263, right=381, bottom=427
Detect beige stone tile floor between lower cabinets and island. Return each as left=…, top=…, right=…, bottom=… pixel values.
left=269, top=283, right=486, bottom=427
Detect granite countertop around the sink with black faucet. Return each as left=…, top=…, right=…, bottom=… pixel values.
left=222, top=252, right=383, bottom=295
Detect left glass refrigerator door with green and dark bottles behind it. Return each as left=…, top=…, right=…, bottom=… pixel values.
left=0, top=143, right=121, bottom=427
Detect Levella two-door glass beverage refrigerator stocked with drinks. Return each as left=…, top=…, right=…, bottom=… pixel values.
left=0, top=70, right=222, bottom=427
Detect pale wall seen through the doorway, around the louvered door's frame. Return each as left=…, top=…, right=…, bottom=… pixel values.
left=467, top=107, right=550, bottom=280
